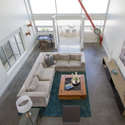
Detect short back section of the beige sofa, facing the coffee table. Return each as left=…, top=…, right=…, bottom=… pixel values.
left=53, top=53, right=85, bottom=72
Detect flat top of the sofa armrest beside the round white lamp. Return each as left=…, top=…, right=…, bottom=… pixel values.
left=20, top=92, right=48, bottom=98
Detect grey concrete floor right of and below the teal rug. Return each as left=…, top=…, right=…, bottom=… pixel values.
left=40, top=44, right=125, bottom=125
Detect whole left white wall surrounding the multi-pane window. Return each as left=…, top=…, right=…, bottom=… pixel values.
left=0, top=0, right=35, bottom=96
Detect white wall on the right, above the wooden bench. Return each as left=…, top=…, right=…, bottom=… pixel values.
left=103, top=0, right=125, bottom=76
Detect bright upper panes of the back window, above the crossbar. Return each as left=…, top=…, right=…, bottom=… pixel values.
left=30, top=0, right=109, bottom=14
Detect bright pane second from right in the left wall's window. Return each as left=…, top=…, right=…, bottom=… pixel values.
left=9, top=37, right=20, bottom=59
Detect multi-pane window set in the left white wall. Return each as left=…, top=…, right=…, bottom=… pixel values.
left=0, top=32, right=25, bottom=71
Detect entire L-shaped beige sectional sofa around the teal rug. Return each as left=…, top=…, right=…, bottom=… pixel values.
left=17, top=52, right=85, bottom=107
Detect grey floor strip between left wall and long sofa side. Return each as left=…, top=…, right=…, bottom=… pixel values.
left=0, top=47, right=40, bottom=125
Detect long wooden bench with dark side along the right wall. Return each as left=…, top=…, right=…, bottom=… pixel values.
left=102, top=57, right=125, bottom=116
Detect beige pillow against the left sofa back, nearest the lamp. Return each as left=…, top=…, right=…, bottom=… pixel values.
left=26, top=77, right=39, bottom=92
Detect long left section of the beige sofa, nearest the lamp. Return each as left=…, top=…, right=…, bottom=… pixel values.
left=17, top=54, right=55, bottom=107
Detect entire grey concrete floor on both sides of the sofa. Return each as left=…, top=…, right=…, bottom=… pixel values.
left=0, top=44, right=125, bottom=125
